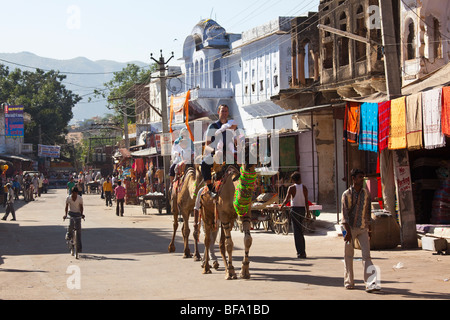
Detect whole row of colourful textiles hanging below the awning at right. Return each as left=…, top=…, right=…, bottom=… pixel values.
left=344, top=87, right=450, bottom=152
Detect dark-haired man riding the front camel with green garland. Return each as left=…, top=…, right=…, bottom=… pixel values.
left=201, top=104, right=237, bottom=199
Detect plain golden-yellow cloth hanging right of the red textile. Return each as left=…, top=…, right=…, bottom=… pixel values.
left=389, top=97, right=406, bottom=150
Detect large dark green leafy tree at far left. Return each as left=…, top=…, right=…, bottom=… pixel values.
left=0, top=65, right=81, bottom=145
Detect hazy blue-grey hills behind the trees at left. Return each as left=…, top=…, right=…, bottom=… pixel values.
left=0, top=52, right=148, bottom=123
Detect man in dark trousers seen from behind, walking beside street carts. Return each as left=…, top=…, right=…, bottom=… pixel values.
left=281, top=172, right=310, bottom=259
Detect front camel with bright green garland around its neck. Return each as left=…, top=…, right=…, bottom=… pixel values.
left=201, top=166, right=254, bottom=280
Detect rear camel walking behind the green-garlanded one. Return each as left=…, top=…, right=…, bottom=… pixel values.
left=169, top=165, right=203, bottom=261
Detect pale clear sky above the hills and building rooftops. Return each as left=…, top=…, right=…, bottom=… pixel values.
left=0, top=0, right=319, bottom=62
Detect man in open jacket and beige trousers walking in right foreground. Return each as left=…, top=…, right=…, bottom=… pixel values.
left=341, top=169, right=380, bottom=292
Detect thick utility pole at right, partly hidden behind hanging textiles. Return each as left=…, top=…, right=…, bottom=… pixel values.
left=379, top=0, right=418, bottom=249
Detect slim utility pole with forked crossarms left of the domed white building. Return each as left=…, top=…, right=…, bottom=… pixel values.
left=150, top=50, right=174, bottom=214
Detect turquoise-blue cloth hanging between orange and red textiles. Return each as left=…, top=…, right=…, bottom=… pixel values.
left=359, top=103, right=378, bottom=152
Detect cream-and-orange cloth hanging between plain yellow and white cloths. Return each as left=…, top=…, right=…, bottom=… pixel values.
left=406, top=93, right=423, bottom=150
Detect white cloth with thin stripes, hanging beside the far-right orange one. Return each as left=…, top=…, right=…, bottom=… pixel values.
left=422, top=88, right=445, bottom=149
